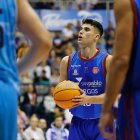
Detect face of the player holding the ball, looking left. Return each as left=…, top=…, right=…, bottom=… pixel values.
left=78, top=24, right=99, bottom=46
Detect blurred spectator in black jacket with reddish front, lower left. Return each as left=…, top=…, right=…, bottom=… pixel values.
left=20, top=84, right=37, bottom=117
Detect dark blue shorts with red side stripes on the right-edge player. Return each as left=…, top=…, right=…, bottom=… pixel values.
left=117, top=89, right=140, bottom=140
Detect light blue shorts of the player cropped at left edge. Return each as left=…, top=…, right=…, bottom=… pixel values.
left=0, top=81, right=18, bottom=140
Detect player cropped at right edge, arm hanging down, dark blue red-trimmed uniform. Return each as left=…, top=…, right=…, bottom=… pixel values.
left=99, top=0, right=140, bottom=140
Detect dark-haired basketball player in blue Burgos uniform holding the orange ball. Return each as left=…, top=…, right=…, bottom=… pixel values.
left=60, top=19, right=111, bottom=140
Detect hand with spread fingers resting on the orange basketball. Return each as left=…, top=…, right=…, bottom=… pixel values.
left=72, top=89, right=90, bottom=105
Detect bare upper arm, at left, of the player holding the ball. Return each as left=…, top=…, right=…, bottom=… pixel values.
left=59, top=56, right=69, bottom=82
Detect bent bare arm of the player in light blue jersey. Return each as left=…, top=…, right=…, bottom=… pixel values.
left=17, top=0, right=52, bottom=74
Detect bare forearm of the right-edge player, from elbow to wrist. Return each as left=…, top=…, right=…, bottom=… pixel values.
left=103, top=58, right=128, bottom=113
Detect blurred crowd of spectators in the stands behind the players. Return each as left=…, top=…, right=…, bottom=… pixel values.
left=15, top=0, right=115, bottom=140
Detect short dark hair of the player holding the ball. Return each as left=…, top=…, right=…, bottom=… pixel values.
left=82, top=18, right=104, bottom=37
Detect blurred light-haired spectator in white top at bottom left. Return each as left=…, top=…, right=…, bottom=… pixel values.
left=23, top=116, right=45, bottom=140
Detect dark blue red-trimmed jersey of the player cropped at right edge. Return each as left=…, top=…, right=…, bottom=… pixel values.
left=123, top=0, right=140, bottom=91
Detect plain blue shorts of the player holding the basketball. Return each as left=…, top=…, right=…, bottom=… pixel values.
left=68, top=116, right=111, bottom=140
